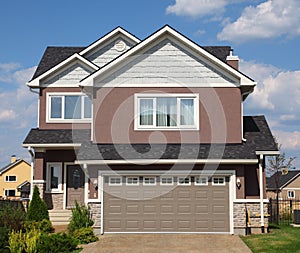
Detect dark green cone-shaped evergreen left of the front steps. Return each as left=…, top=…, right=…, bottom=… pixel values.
left=26, top=186, right=49, bottom=221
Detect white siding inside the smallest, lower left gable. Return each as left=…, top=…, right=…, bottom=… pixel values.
left=42, top=63, right=92, bottom=87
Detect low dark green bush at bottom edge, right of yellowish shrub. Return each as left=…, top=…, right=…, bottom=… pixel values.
left=37, top=233, right=77, bottom=253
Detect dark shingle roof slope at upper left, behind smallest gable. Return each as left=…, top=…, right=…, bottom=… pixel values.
left=32, top=47, right=85, bottom=80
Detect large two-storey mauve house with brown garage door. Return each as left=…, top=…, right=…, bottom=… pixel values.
left=23, top=26, right=279, bottom=234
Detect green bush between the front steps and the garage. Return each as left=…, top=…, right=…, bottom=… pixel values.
left=68, top=201, right=94, bottom=234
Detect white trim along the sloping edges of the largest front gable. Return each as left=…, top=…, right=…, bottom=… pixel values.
left=80, top=25, right=256, bottom=92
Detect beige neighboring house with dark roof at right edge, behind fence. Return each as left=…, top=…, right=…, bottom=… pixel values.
left=267, top=170, right=300, bottom=200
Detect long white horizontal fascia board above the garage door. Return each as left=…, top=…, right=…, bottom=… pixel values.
left=75, top=159, right=258, bottom=165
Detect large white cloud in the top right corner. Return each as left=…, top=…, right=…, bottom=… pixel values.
left=218, top=0, right=300, bottom=42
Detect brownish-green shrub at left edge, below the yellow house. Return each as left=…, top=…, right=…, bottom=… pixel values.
left=0, top=204, right=26, bottom=230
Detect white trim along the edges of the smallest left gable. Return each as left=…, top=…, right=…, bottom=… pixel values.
left=26, top=53, right=99, bottom=88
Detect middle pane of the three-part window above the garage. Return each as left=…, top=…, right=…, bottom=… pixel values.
left=156, top=98, right=177, bottom=126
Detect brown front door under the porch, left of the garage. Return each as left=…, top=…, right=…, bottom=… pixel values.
left=67, top=165, right=85, bottom=208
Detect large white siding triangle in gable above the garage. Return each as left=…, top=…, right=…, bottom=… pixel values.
left=97, top=39, right=237, bottom=86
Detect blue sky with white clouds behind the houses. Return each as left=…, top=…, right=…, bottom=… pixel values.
left=0, top=0, right=300, bottom=168
